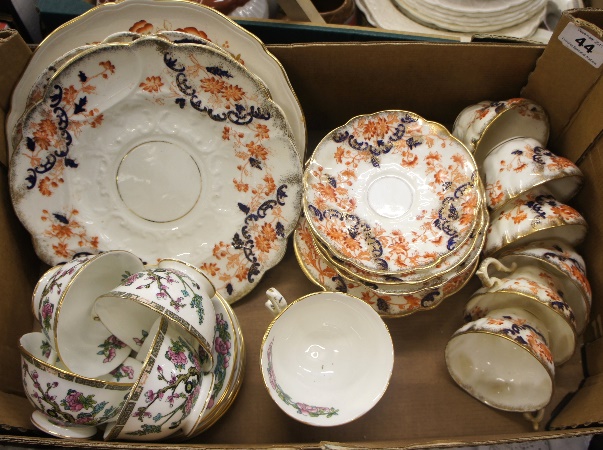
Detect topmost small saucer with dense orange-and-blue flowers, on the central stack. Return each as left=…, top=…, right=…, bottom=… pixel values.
left=303, top=111, right=484, bottom=275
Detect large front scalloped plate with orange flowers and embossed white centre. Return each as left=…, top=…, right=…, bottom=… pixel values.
left=10, top=37, right=302, bottom=302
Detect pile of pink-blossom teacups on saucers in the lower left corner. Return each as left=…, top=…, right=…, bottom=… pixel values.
left=20, top=250, right=244, bottom=440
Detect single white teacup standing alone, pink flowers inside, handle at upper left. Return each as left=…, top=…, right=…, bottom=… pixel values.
left=260, top=289, right=394, bottom=426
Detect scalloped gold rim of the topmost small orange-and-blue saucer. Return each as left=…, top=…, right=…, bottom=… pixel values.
left=302, top=109, right=486, bottom=275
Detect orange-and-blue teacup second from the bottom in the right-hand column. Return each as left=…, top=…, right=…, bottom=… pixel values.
left=465, top=264, right=577, bottom=364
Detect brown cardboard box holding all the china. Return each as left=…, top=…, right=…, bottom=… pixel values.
left=0, top=10, right=603, bottom=448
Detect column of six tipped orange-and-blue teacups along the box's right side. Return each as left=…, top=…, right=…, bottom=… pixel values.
left=446, top=99, right=591, bottom=413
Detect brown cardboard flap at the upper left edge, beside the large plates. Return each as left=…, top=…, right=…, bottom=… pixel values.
left=0, top=30, right=31, bottom=166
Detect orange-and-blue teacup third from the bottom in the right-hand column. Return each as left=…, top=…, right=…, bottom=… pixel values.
left=493, top=241, right=592, bottom=334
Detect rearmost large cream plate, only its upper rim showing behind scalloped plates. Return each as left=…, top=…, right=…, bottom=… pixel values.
left=6, top=0, right=307, bottom=161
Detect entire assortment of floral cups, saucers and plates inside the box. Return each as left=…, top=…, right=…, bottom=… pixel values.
left=7, top=0, right=591, bottom=441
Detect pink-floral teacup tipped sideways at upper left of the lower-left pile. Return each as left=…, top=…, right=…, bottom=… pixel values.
left=32, top=250, right=143, bottom=377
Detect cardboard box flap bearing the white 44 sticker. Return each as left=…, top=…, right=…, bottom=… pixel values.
left=521, top=9, right=603, bottom=161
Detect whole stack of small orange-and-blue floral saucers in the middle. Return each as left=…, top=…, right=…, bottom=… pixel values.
left=294, top=111, right=488, bottom=316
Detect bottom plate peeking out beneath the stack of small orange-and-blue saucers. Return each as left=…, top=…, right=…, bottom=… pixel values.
left=293, top=217, right=479, bottom=318
